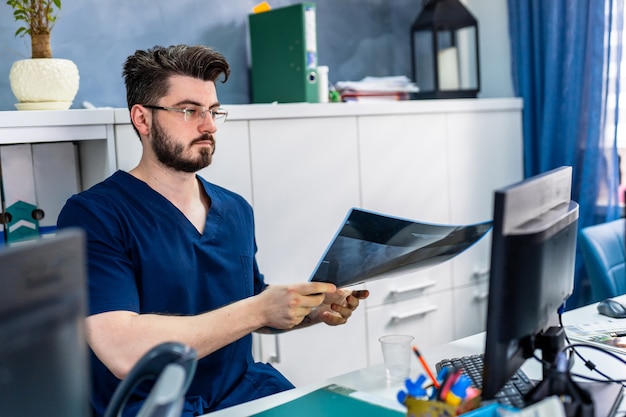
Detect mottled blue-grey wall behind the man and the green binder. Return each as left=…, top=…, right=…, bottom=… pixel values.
left=0, top=0, right=422, bottom=110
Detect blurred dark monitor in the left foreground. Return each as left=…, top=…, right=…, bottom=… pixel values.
left=0, top=229, right=91, bottom=417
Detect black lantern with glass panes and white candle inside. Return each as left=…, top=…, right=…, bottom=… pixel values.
left=411, top=0, right=480, bottom=99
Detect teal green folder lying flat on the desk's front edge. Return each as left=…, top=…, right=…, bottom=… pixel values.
left=253, top=384, right=406, bottom=417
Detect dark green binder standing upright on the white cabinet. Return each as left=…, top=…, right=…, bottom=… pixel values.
left=248, top=3, right=318, bottom=103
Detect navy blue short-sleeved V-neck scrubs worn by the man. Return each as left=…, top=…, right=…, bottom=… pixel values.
left=58, top=171, right=293, bottom=416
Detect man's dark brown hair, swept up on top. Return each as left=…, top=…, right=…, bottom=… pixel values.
left=122, top=45, right=230, bottom=109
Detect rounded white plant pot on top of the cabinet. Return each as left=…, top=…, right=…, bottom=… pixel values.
left=9, top=58, right=80, bottom=110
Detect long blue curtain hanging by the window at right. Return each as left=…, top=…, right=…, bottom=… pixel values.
left=508, top=0, right=623, bottom=309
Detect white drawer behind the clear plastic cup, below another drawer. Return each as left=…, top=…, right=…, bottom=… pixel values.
left=366, top=291, right=454, bottom=365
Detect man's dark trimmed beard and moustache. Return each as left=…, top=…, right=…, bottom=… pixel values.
left=151, top=118, right=215, bottom=173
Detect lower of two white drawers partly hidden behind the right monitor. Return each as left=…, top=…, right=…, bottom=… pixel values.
left=454, top=281, right=489, bottom=339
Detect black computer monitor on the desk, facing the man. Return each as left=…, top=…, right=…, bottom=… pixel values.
left=482, top=167, right=578, bottom=399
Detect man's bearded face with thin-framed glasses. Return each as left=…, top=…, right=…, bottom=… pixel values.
left=150, top=76, right=219, bottom=173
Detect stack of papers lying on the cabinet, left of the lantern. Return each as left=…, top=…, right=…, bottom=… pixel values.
left=335, top=75, right=419, bottom=101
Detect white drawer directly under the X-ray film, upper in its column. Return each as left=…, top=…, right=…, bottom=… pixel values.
left=366, top=262, right=452, bottom=308
